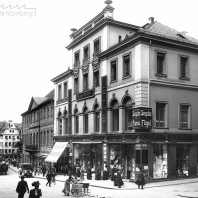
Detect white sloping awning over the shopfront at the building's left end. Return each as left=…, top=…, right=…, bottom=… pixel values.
left=45, top=142, right=68, bottom=162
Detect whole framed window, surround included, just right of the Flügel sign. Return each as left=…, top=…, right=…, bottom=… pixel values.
left=155, top=102, right=168, bottom=128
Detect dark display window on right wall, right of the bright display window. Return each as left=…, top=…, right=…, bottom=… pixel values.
left=176, top=144, right=190, bottom=177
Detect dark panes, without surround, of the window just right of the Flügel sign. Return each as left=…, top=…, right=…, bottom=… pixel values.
left=155, top=103, right=166, bottom=128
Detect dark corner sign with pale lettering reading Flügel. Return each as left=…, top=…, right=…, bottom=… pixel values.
left=132, top=107, right=152, bottom=129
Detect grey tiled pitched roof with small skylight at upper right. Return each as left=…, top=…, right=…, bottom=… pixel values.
left=140, top=21, right=198, bottom=44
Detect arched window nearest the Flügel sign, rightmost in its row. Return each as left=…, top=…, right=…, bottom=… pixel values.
left=123, top=96, right=132, bottom=130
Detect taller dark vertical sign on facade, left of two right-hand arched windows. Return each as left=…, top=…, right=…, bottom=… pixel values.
left=101, top=76, right=107, bottom=133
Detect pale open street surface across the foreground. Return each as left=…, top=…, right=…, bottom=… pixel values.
left=0, top=169, right=198, bottom=198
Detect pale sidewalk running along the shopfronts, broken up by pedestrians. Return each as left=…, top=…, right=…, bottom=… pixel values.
left=9, top=166, right=198, bottom=198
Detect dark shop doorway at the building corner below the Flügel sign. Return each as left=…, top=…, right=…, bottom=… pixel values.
left=135, top=144, right=149, bottom=182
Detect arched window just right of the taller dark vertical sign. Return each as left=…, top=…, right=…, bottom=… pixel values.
left=111, top=99, right=119, bottom=131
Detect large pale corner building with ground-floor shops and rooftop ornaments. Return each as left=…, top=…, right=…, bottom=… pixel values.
left=46, top=1, right=198, bottom=182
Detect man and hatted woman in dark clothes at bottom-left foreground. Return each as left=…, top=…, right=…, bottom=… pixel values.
left=16, top=175, right=42, bottom=198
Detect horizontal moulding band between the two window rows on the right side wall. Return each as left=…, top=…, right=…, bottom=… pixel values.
left=150, top=79, right=198, bottom=90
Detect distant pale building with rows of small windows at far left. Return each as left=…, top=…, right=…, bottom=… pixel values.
left=0, top=120, right=21, bottom=161
